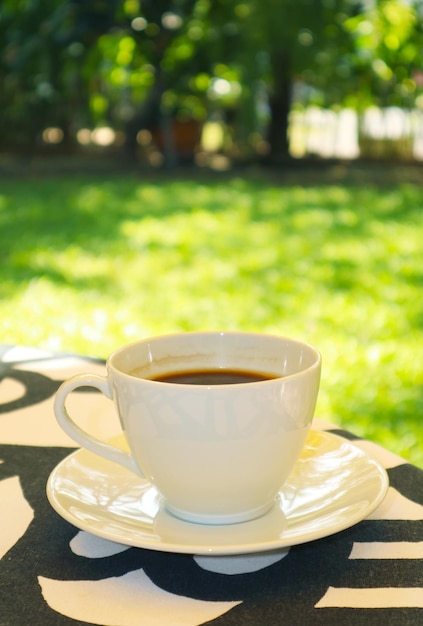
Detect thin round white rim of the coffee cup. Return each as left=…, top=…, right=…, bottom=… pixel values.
left=106, top=330, right=322, bottom=389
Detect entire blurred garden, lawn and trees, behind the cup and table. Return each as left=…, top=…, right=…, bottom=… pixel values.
left=0, top=0, right=423, bottom=467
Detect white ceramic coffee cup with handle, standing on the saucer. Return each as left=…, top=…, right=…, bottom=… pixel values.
left=54, top=332, right=321, bottom=524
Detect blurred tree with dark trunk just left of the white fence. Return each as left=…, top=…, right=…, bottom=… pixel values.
left=234, top=0, right=357, bottom=160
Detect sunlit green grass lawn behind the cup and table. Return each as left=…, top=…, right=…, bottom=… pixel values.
left=0, top=168, right=423, bottom=467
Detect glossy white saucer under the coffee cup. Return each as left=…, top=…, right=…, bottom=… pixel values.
left=47, top=431, right=389, bottom=555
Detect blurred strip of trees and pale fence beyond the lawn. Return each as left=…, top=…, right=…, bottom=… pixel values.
left=0, top=0, right=423, bottom=168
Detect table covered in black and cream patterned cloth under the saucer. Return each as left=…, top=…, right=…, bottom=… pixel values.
left=0, top=345, right=423, bottom=626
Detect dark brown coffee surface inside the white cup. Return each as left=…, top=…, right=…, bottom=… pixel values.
left=130, top=368, right=280, bottom=385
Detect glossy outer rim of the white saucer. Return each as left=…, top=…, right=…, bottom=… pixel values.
left=46, top=429, right=389, bottom=556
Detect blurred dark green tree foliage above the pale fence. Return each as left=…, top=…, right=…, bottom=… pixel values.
left=0, top=0, right=423, bottom=161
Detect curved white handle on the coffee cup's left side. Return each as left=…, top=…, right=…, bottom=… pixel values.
left=54, top=374, right=144, bottom=476
